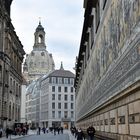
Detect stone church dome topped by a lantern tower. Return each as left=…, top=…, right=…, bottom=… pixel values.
left=23, top=22, right=55, bottom=82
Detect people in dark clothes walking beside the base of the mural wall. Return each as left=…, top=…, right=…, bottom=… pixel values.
left=71, top=126, right=96, bottom=140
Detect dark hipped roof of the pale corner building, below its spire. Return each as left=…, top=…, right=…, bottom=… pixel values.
left=48, top=69, right=75, bottom=78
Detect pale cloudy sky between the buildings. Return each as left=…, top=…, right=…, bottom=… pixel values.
left=11, top=0, right=84, bottom=72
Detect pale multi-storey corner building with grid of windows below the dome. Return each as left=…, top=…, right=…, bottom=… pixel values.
left=26, top=65, right=75, bottom=129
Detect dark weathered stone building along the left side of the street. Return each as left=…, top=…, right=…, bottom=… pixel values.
left=0, top=0, right=25, bottom=128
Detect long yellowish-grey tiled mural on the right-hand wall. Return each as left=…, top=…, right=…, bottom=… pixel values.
left=77, top=0, right=140, bottom=117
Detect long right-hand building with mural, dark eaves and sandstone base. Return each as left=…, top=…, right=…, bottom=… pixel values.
left=75, top=0, right=140, bottom=140
